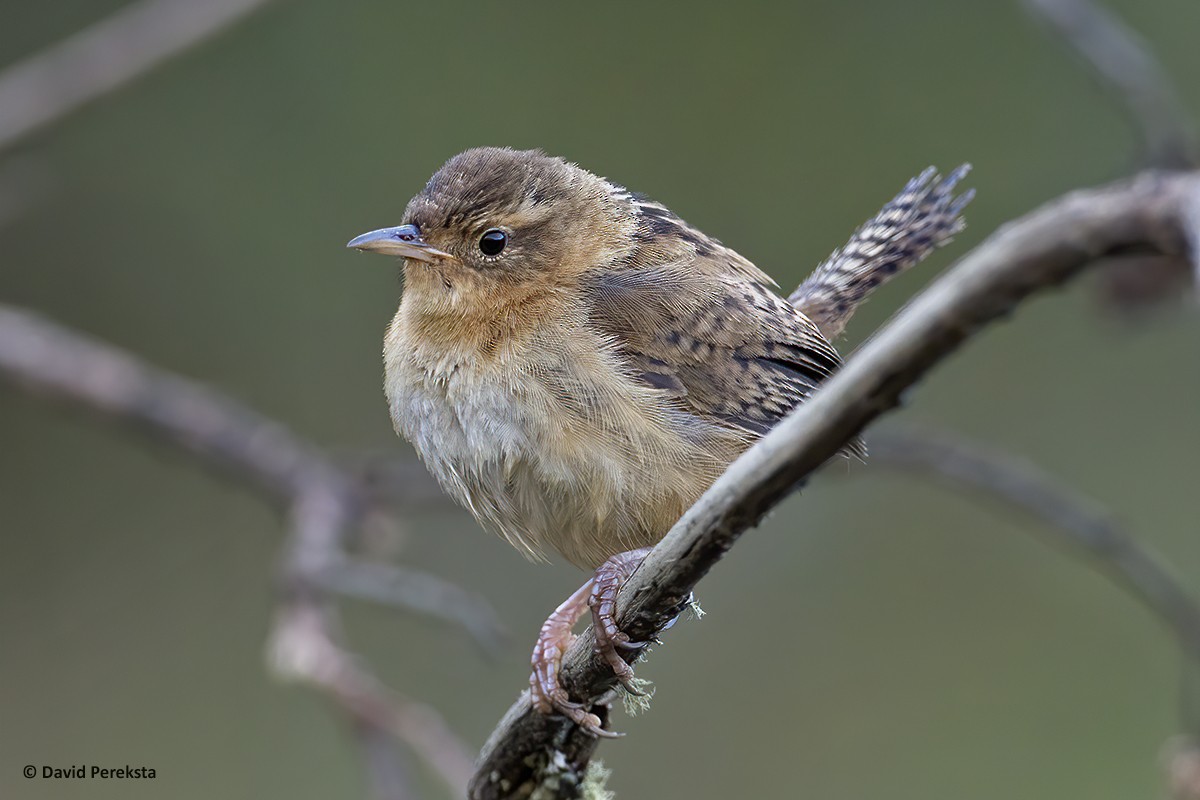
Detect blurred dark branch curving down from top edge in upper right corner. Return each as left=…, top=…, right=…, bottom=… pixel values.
left=1025, top=0, right=1200, bottom=169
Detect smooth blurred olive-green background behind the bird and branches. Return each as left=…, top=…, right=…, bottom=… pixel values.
left=0, top=0, right=1200, bottom=800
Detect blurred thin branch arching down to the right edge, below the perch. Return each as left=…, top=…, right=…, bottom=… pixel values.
left=870, top=431, right=1200, bottom=658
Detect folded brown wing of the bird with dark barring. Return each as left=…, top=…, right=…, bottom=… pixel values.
left=586, top=256, right=857, bottom=450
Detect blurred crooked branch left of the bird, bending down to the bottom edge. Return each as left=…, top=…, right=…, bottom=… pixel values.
left=0, top=306, right=482, bottom=795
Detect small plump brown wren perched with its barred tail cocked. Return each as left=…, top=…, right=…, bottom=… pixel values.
left=348, top=148, right=970, bottom=734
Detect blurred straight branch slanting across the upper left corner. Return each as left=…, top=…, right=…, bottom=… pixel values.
left=0, top=0, right=276, bottom=150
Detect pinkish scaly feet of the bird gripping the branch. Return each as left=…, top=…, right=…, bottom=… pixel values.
left=529, top=547, right=650, bottom=738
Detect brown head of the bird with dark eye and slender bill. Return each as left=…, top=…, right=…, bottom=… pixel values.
left=347, top=148, right=635, bottom=305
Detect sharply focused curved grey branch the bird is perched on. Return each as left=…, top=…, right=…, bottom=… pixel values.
left=470, top=173, right=1200, bottom=799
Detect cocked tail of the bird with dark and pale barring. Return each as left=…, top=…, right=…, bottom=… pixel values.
left=787, top=164, right=974, bottom=341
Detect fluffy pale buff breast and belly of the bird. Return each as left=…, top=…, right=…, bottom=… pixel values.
left=385, top=307, right=739, bottom=567
